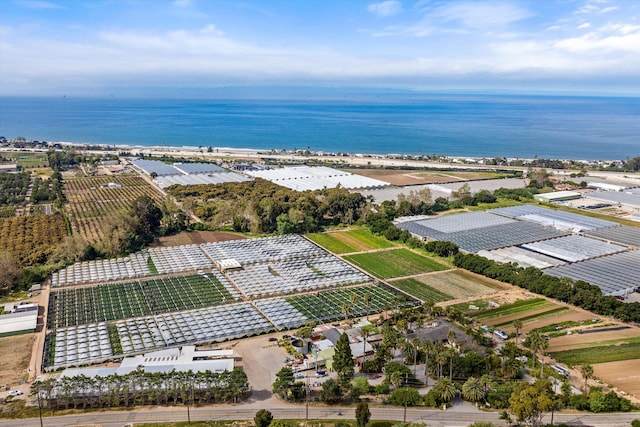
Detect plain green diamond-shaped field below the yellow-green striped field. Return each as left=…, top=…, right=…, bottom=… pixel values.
left=344, top=249, right=448, bottom=279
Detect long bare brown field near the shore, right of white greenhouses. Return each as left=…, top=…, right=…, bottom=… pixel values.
left=348, top=169, right=495, bottom=186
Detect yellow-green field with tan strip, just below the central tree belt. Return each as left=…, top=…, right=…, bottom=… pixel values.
left=307, top=228, right=395, bottom=254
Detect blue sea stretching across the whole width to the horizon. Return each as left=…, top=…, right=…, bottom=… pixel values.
left=0, top=94, right=640, bottom=160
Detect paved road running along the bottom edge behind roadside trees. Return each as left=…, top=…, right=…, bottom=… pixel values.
left=0, top=405, right=638, bottom=427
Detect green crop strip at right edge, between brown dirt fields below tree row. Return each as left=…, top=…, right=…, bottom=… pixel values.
left=550, top=338, right=640, bottom=366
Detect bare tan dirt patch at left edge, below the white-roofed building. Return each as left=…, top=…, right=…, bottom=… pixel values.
left=0, top=334, right=33, bottom=386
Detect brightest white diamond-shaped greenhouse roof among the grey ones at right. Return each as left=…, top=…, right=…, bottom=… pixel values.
left=522, top=235, right=626, bottom=262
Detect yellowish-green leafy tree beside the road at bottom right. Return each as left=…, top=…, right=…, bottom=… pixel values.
left=509, top=380, right=553, bottom=426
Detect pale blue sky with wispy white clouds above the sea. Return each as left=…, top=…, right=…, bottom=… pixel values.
left=0, top=0, right=640, bottom=96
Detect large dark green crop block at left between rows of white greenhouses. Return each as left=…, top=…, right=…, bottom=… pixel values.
left=48, top=274, right=235, bottom=329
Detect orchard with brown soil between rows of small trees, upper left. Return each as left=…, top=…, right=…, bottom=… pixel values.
left=64, top=175, right=163, bottom=243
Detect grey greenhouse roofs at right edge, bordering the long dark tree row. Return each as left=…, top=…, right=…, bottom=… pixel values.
left=545, top=251, right=640, bottom=295
